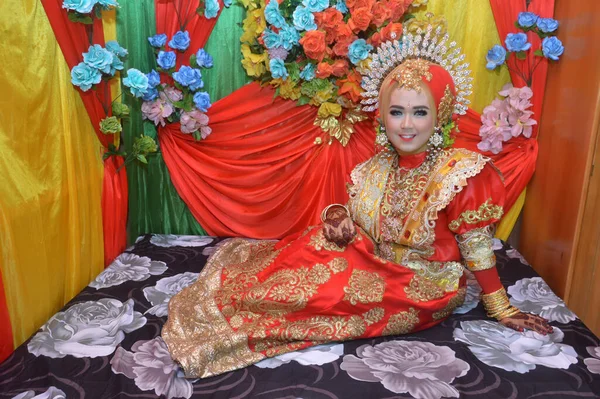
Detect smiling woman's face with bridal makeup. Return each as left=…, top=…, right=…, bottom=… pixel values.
left=383, top=87, right=436, bottom=155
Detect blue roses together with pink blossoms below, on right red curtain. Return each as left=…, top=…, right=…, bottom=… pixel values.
left=477, top=12, right=565, bottom=154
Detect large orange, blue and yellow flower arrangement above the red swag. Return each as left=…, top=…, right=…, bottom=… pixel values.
left=240, top=0, right=427, bottom=145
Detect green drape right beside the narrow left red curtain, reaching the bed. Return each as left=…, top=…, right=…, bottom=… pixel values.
left=117, top=0, right=206, bottom=242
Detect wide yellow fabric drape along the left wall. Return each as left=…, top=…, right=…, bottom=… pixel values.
left=0, top=0, right=103, bottom=345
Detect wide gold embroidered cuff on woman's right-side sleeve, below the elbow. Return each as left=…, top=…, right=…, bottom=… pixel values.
left=456, top=225, right=496, bottom=271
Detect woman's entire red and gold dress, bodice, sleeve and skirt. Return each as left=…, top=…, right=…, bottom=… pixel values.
left=162, top=149, right=504, bottom=377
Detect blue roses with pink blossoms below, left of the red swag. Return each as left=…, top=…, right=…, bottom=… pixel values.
left=139, top=31, right=213, bottom=140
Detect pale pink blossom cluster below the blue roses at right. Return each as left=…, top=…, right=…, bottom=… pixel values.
left=477, top=83, right=537, bottom=154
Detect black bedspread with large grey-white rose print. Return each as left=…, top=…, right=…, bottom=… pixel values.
left=0, top=235, right=600, bottom=399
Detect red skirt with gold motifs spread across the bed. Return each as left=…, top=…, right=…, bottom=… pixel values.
left=162, top=226, right=466, bottom=377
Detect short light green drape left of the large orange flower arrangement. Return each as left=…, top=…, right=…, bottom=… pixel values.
left=202, top=4, right=252, bottom=102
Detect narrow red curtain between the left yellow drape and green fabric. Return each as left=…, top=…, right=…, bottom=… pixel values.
left=42, top=0, right=127, bottom=265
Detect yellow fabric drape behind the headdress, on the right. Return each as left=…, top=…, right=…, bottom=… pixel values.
left=416, top=0, right=525, bottom=240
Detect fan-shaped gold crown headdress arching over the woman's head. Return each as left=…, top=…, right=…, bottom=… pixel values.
left=361, top=25, right=473, bottom=115
